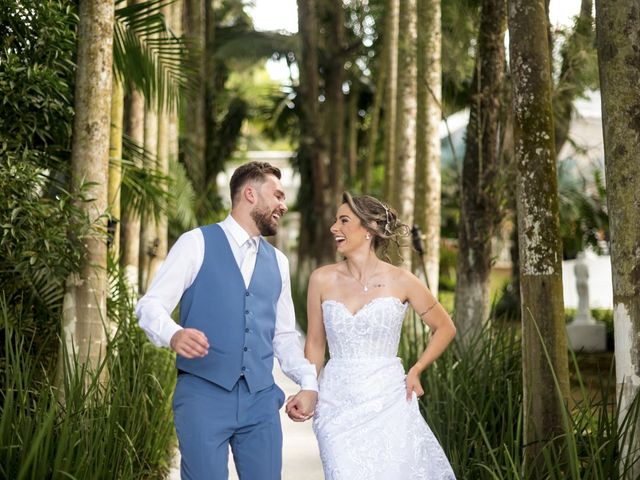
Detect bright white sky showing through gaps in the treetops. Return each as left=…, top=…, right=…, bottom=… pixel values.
left=246, top=0, right=580, bottom=82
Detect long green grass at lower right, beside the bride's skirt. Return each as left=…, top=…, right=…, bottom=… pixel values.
left=400, top=322, right=640, bottom=480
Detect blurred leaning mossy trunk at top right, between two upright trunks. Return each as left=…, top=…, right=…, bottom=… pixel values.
left=553, top=0, right=594, bottom=155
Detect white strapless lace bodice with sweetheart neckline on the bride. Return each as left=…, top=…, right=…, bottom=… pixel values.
left=322, top=297, right=407, bottom=359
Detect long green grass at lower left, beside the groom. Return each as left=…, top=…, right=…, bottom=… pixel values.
left=0, top=266, right=175, bottom=479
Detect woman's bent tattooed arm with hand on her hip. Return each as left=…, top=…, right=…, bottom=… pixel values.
left=403, top=272, right=456, bottom=400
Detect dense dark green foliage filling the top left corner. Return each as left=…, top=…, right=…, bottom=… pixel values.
left=0, top=0, right=77, bottom=169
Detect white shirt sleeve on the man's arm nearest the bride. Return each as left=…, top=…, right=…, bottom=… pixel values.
left=273, top=250, right=318, bottom=392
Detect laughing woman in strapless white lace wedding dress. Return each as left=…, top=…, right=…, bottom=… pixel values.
left=287, top=193, right=456, bottom=480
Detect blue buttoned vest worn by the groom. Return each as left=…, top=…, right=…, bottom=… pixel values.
left=176, top=224, right=282, bottom=393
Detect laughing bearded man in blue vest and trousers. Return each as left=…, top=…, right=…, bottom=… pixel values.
left=136, top=162, right=318, bottom=480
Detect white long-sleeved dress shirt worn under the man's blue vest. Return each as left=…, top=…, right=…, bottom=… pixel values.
left=136, top=215, right=318, bottom=391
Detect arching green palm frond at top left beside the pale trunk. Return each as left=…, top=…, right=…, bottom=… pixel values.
left=113, top=0, right=194, bottom=110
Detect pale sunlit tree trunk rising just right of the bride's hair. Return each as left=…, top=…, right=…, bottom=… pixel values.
left=414, top=0, right=442, bottom=296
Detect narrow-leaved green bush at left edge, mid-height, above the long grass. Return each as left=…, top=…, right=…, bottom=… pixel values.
left=0, top=160, right=90, bottom=334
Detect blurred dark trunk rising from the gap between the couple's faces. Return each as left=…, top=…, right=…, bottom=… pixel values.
left=298, top=0, right=334, bottom=266
